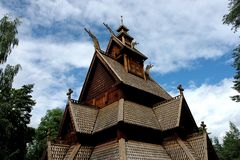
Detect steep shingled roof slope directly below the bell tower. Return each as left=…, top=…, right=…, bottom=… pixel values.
left=98, top=53, right=172, bottom=99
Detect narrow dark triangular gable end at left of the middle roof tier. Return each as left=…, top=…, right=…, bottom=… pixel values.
left=58, top=105, right=76, bottom=143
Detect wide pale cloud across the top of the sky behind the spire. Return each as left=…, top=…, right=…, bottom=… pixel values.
left=21, top=0, right=237, bottom=73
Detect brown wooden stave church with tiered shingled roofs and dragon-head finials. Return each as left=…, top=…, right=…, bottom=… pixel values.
left=43, top=20, right=218, bottom=160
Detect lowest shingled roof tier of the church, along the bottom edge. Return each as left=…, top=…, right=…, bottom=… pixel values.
left=48, top=132, right=215, bottom=160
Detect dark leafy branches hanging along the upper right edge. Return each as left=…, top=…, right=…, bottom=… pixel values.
left=223, top=0, right=240, bottom=102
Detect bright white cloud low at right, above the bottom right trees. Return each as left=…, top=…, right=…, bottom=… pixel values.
left=180, top=79, right=240, bottom=138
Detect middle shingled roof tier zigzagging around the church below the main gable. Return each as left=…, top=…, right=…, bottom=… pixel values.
left=63, top=96, right=194, bottom=134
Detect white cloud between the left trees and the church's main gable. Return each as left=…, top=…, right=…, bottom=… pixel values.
left=8, top=39, right=93, bottom=127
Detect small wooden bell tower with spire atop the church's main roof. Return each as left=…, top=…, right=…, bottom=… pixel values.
left=105, top=19, right=147, bottom=80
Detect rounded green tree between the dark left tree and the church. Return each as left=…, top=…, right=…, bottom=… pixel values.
left=26, top=108, right=63, bottom=160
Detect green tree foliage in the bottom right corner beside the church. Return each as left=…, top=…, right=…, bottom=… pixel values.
left=214, top=122, right=240, bottom=160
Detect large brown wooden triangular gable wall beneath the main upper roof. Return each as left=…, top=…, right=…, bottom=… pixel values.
left=79, top=51, right=120, bottom=108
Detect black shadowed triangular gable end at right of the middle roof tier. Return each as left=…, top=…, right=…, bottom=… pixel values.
left=179, top=96, right=198, bottom=135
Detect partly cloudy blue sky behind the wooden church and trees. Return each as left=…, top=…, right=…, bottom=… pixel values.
left=0, top=0, right=240, bottom=139
